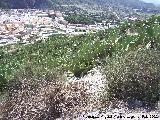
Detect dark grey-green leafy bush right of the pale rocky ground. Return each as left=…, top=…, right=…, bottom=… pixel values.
left=105, top=50, right=160, bottom=107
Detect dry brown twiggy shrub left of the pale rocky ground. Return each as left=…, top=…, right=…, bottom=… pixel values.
left=2, top=71, right=89, bottom=120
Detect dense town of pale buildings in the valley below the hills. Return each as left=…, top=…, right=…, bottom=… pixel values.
left=0, top=9, right=140, bottom=46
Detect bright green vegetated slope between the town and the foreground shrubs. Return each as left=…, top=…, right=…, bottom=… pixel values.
left=0, top=16, right=160, bottom=89
